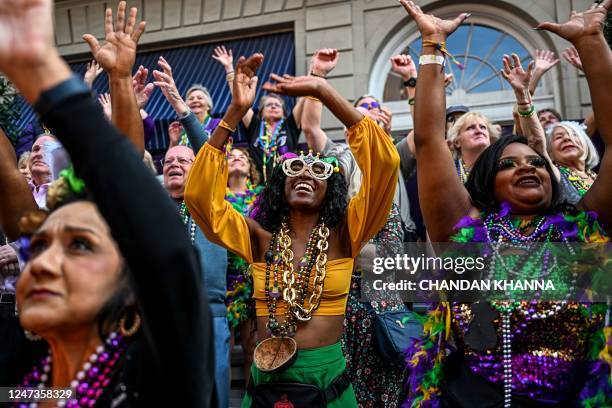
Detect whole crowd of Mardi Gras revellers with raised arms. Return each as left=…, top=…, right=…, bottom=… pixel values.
left=0, top=0, right=612, bottom=408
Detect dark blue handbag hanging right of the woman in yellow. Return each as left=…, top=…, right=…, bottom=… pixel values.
left=370, top=306, right=423, bottom=365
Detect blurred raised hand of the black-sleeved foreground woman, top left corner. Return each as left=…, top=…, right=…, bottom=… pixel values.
left=0, top=0, right=54, bottom=72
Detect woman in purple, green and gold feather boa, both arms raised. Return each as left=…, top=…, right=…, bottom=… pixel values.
left=401, top=0, right=612, bottom=408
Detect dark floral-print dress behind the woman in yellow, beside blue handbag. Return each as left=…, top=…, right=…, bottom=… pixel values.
left=342, top=204, right=405, bottom=408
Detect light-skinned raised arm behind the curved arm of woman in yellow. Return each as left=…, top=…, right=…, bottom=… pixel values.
left=301, top=48, right=340, bottom=152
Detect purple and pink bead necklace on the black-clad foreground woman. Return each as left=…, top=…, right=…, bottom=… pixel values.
left=15, top=332, right=125, bottom=408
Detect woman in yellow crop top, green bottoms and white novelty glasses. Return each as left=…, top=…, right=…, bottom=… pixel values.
left=185, top=54, right=399, bottom=408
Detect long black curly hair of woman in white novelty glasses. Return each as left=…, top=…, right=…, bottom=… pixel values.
left=253, top=157, right=349, bottom=232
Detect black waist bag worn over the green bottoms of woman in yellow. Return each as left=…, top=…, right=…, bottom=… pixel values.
left=247, top=371, right=351, bottom=408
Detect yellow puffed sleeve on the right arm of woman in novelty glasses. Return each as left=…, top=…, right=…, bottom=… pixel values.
left=347, top=117, right=400, bottom=257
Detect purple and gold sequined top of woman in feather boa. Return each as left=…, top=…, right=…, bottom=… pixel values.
left=453, top=303, right=603, bottom=401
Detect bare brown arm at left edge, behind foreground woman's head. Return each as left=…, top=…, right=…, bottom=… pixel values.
left=0, top=129, right=38, bottom=244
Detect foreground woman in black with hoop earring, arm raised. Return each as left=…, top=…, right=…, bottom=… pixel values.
left=0, top=0, right=214, bottom=407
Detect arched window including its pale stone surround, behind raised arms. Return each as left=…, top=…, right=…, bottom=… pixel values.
left=368, top=2, right=560, bottom=134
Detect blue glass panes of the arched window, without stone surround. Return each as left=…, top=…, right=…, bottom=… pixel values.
left=383, top=24, right=532, bottom=101
